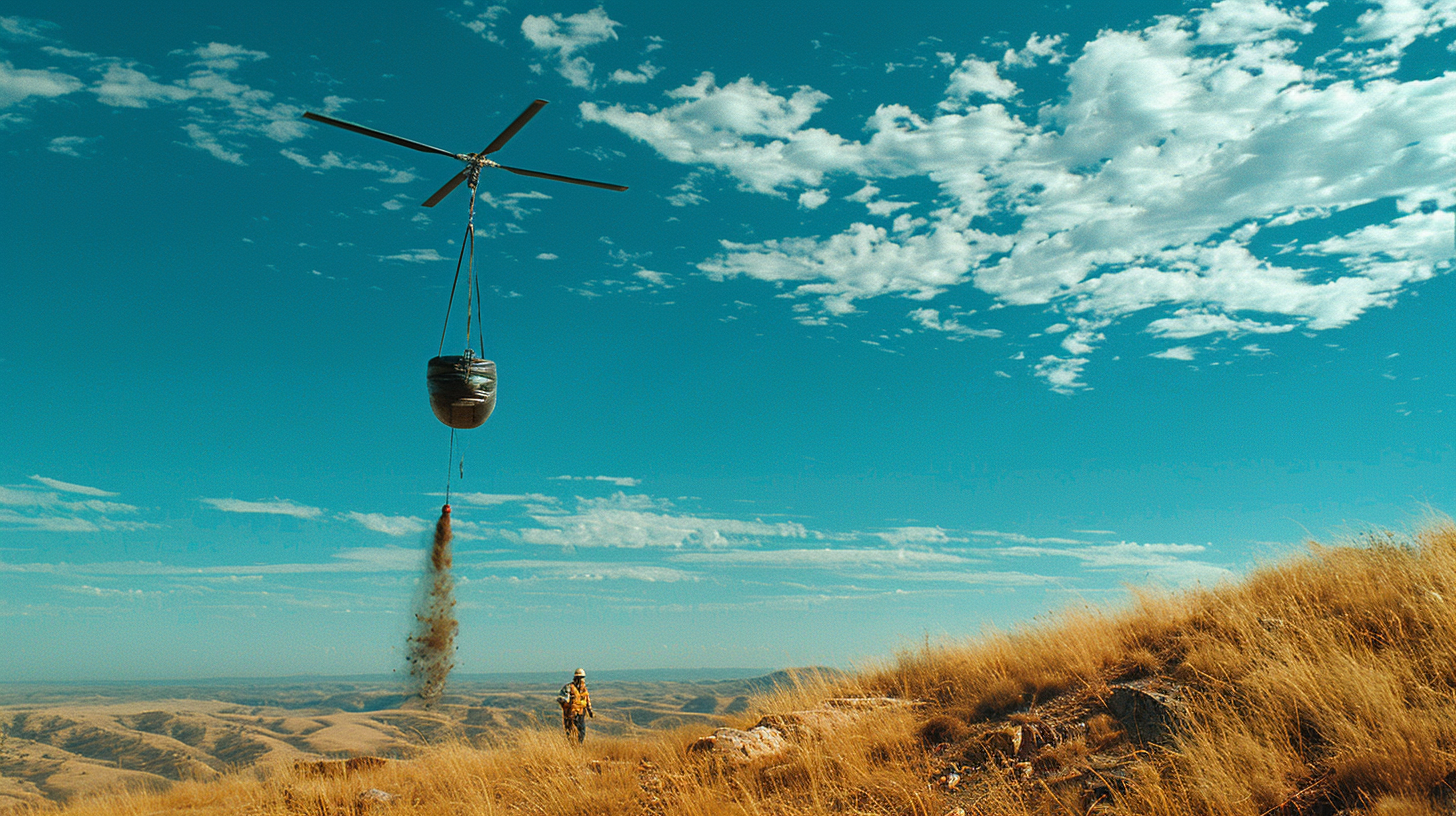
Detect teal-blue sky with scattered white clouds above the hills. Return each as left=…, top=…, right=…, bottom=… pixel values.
left=0, top=0, right=1456, bottom=679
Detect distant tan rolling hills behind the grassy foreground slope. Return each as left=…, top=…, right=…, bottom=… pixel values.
left=0, top=669, right=788, bottom=810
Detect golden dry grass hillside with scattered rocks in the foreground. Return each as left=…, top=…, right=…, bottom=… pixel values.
left=19, top=525, right=1456, bottom=816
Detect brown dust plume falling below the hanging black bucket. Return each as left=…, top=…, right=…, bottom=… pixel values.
left=408, top=504, right=460, bottom=707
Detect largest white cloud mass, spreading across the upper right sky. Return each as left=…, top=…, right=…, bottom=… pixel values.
left=582, top=8, right=1456, bottom=392
